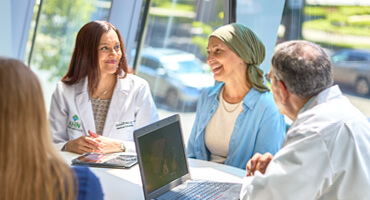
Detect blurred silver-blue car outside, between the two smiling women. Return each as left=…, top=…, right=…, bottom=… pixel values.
left=136, top=47, right=215, bottom=108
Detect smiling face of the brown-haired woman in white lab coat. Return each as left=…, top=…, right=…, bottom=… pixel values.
left=98, top=29, right=122, bottom=76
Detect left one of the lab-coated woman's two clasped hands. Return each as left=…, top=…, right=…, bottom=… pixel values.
left=65, top=136, right=102, bottom=154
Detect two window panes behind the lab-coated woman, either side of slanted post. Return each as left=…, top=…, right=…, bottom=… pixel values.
left=25, top=0, right=227, bottom=142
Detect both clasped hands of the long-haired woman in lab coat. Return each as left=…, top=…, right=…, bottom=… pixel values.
left=65, top=131, right=121, bottom=154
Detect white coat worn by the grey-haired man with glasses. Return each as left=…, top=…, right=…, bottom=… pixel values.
left=240, top=86, right=370, bottom=200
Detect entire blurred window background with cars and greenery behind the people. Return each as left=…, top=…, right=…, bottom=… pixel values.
left=0, top=0, right=370, bottom=144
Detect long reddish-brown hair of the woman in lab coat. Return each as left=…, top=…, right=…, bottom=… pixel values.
left=62, top=21, right=129, bottom=94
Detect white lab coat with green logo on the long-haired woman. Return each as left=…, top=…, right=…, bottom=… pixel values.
left=49, top=74, right=159, bottom=152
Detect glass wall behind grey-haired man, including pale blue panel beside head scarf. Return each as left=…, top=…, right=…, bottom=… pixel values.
left=236, top=0, right=370, bottom=117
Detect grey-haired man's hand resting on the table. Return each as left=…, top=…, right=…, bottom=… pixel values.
left=246, top=153, right=273, bottom=176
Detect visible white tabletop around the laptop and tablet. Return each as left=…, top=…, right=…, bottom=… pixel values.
left=61, top=152, right=246, bottom=200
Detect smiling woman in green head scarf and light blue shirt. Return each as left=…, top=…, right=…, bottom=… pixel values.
left=187, top=23, right=285, bottom=169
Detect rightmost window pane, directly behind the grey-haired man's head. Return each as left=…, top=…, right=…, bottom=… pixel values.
left=278, top=0, right=370, bottom=117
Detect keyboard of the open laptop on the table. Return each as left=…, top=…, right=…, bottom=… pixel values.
left=165, top=181, right=235, bottom=200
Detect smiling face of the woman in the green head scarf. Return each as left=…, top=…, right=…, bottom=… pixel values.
left=207, top=37, right=247, bottom=82
